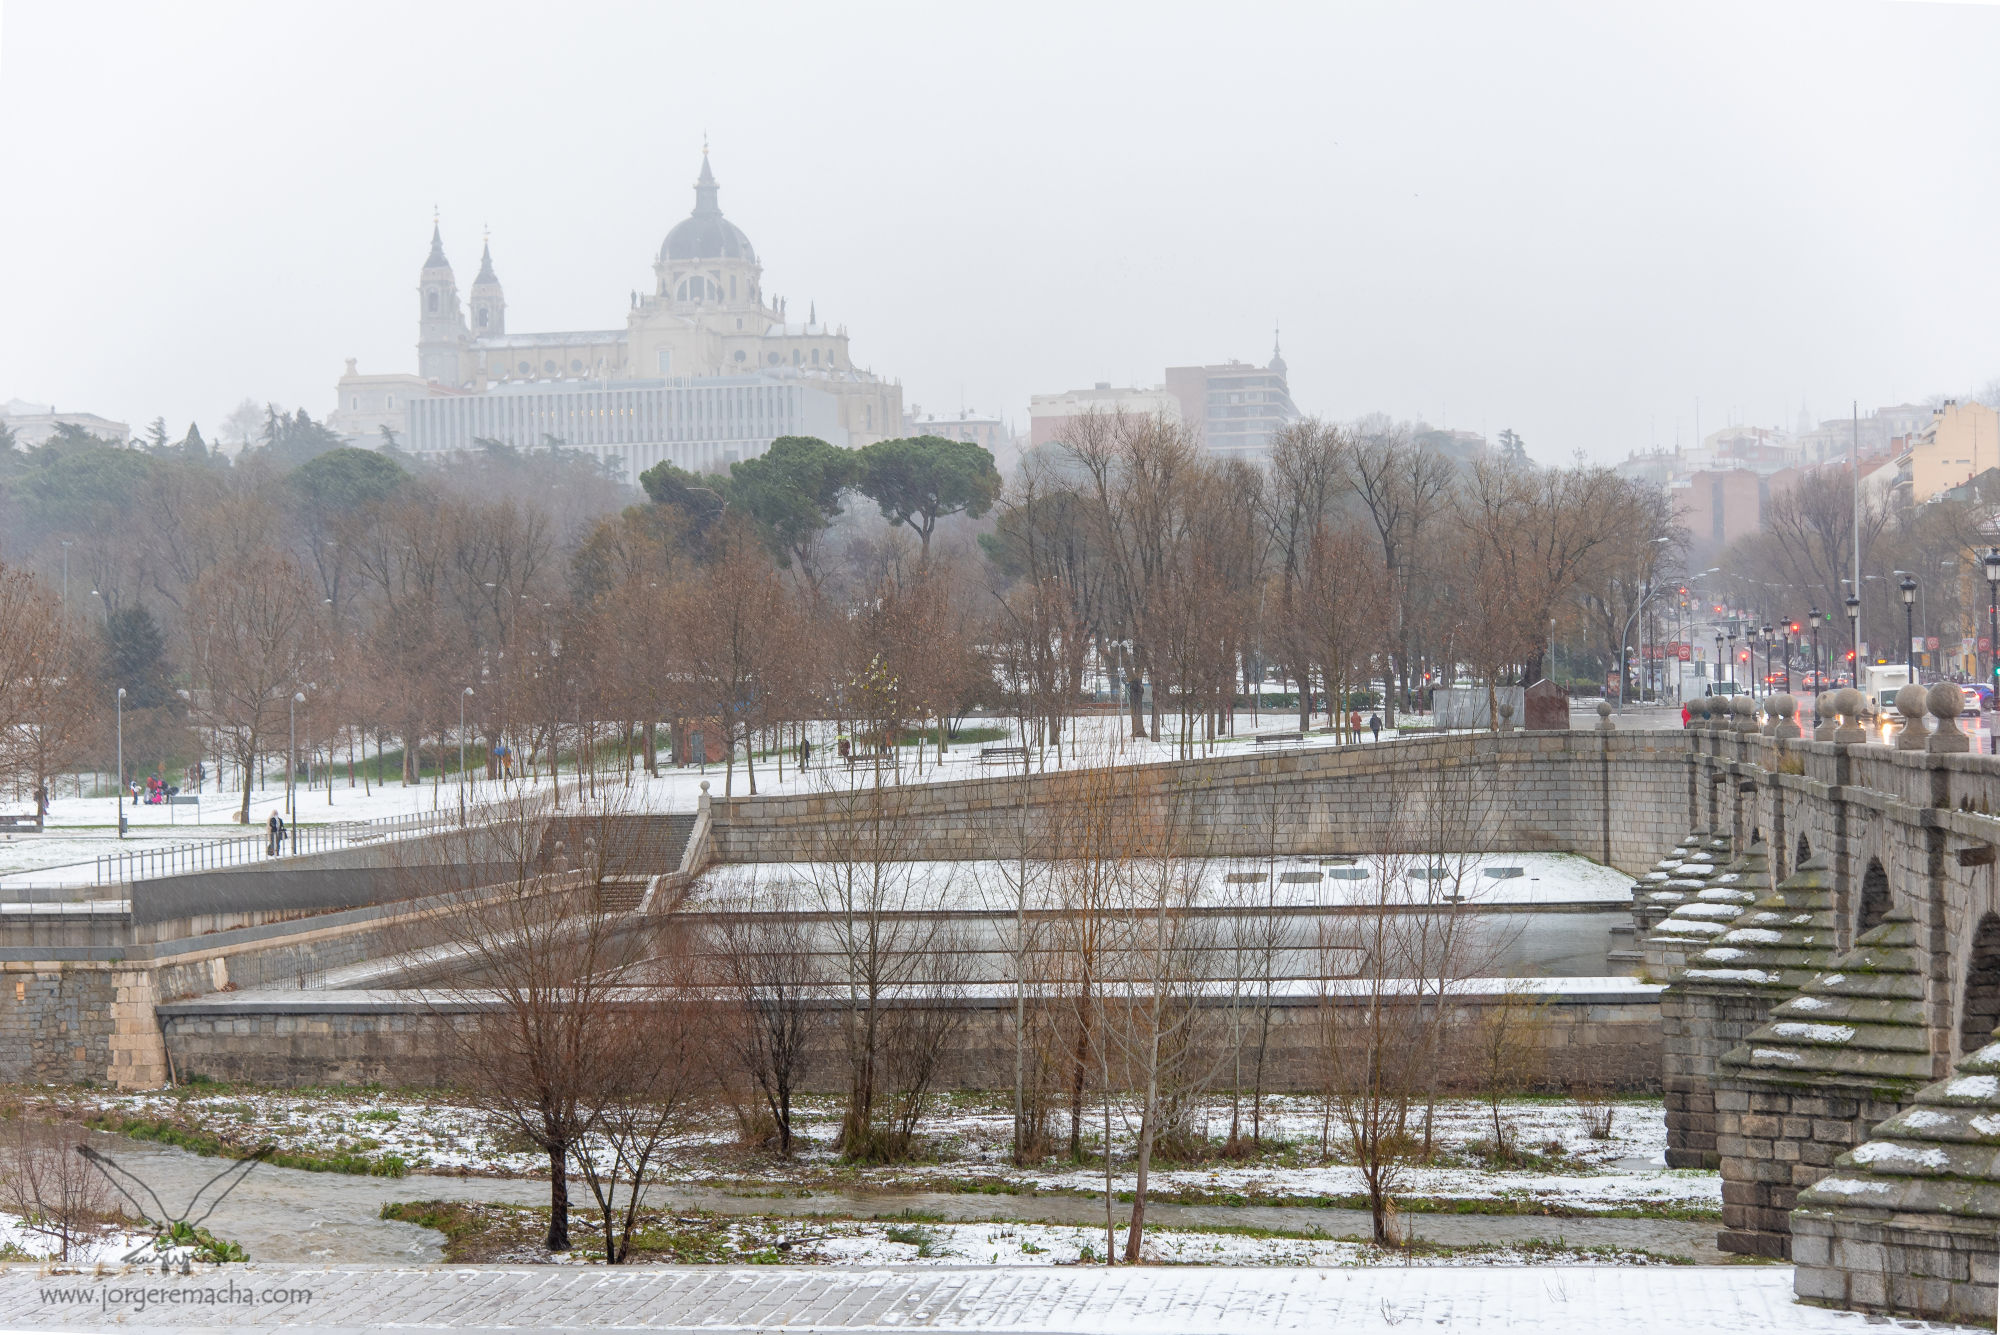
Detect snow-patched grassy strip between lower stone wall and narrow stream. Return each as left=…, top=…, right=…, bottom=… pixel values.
left=74, top=1089, right=1720, bottom=1213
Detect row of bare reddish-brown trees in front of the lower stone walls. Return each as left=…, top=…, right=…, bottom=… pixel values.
left=404, top=763, right=1540, bottom=1261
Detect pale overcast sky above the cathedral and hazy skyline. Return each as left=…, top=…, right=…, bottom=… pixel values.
left=0, top=0, right=2000, bottom=460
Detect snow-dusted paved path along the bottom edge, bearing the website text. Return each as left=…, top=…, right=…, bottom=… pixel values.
left=0, top=1265, right=1964, bottom=1335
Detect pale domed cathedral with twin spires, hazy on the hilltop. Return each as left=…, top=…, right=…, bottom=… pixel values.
left=328, top=150, right=902, bottom=482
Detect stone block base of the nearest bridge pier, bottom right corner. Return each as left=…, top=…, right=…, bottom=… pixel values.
left=1792, top=1209, right=2000, bottom=1327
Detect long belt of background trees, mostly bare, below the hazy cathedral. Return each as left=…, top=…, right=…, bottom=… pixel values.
left=0, top=403, right=1678, bottom=813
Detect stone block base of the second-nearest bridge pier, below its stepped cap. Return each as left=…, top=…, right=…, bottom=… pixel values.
left=1714, top=1075, right=1902, bottom=1259
